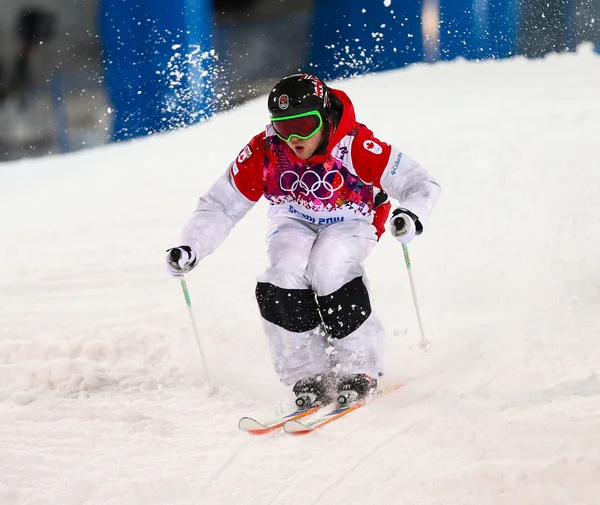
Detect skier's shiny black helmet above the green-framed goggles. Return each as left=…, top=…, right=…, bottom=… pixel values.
left=268, top=74, right=331, bottom=121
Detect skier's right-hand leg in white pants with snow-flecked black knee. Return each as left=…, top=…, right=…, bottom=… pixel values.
left=307, top=220, right=385, bottom=377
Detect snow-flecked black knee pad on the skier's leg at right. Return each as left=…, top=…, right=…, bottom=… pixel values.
left=317, top=277, right=371, bottom=339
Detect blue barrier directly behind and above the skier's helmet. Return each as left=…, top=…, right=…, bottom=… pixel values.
left=308, top=0, right=423, bottom=79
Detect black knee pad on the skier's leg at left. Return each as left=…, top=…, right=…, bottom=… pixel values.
left=256, top=282, right=321, bottom=333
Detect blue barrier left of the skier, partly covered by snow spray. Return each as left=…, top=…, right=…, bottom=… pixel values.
left=100, top=0, right=212, bottom=140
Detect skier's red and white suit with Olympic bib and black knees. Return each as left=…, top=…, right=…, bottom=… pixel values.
left=182, top=89, right=440, bottom=385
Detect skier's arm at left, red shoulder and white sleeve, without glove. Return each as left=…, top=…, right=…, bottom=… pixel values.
left=181, top=137, right=262, bottom=261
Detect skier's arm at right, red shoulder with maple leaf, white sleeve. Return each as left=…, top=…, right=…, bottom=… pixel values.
left=352, top=125, right=440, bottom=235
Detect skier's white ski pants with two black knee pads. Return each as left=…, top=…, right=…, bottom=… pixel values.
left=257, top=217, right=385, bottom=385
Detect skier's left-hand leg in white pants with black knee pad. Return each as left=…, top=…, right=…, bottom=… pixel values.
left=256, top=218, right=327, bottom=386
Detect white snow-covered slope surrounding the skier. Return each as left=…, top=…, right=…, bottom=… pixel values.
left=0, top=46, right=600, bottom=505
